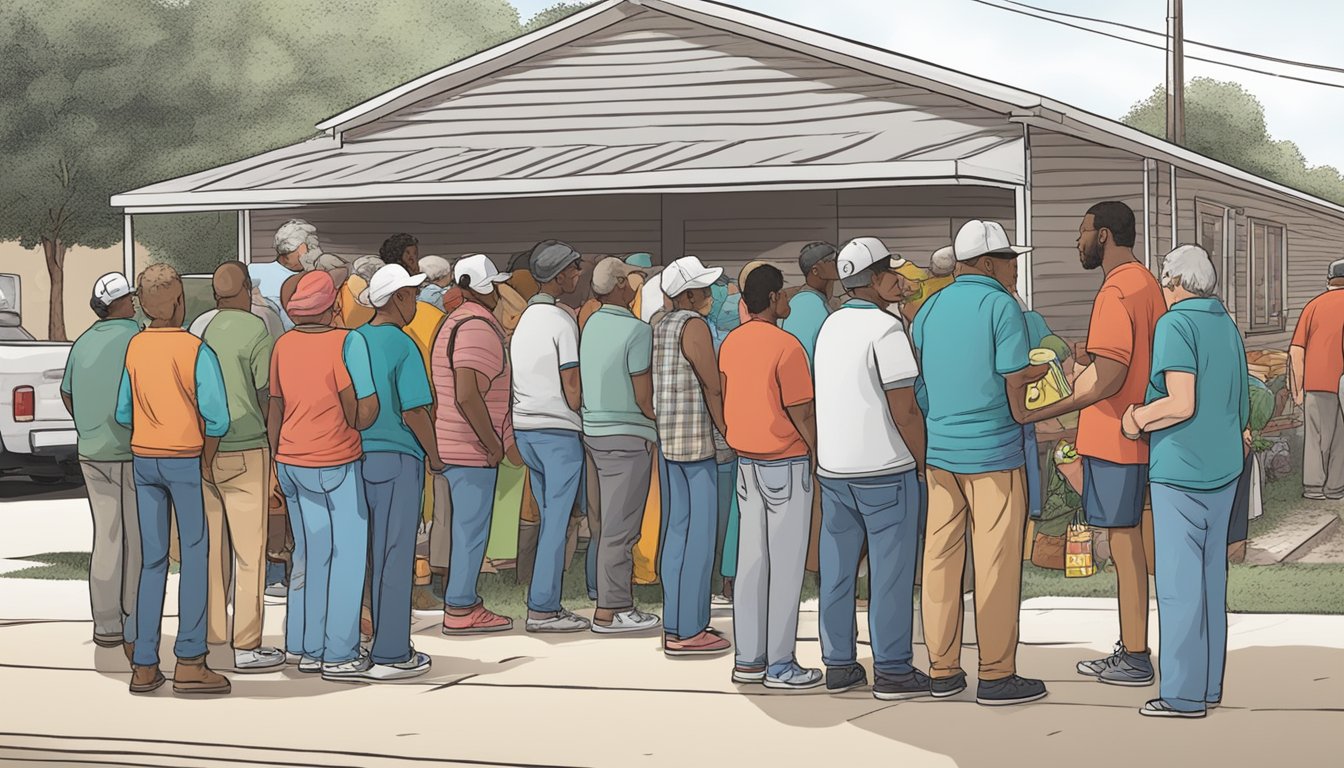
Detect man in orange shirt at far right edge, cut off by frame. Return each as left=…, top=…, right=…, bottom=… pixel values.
left=1288, top=260, right=1344, bottom=500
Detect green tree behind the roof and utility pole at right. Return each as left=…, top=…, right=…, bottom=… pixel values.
left=1124, top=78, right=1344, bottom=203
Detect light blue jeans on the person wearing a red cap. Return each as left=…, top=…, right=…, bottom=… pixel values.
left=276, top=461, right=368, bottom=664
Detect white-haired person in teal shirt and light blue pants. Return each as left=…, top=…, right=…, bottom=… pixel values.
left=1121, top=245, right=1250, bottom=717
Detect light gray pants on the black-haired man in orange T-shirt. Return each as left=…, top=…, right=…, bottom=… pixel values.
left=732, top=457, right=813, bottom=668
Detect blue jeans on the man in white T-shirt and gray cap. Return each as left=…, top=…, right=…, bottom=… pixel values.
left=513, top=429, right=585, bottom=613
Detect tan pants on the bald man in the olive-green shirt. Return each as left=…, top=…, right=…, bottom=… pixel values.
left=203, top=448, right=270, bottom=651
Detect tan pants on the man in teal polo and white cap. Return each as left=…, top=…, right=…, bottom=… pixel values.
left=921, top=467, right=1027, bottom=681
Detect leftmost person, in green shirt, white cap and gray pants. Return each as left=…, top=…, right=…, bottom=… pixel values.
left=60, top=272, right=140, bottom=658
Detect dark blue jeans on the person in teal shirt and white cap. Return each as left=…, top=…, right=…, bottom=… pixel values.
left=363, top=451, right=425, bottom=664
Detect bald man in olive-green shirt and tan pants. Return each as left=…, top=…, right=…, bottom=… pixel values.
left=191, top=261, right=285, bottom=673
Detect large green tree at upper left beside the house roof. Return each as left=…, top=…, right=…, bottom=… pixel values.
left=0, top=0, right=521, bottom=339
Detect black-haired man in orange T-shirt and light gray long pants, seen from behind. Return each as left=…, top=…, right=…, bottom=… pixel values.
left=719, top=265, right=823, bottom=690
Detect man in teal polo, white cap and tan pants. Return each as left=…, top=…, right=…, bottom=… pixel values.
left=911, top=221, right=1046, bottom=706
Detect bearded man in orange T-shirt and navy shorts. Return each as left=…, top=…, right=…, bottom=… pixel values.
left=1032, top=202, right=1167, bottom=686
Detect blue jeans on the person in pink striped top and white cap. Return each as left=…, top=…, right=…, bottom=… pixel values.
left=444, top=467, right=499, bottom=608
